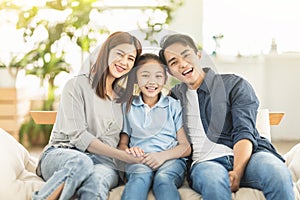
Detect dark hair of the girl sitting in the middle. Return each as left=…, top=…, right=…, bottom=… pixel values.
left=124, top=53, right=168, bottom=112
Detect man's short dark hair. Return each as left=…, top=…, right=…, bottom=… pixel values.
left=159, top=33, right=198, bottom=65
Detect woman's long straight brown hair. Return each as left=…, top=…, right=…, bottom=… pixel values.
left=89, top=31, right=142, bottom=103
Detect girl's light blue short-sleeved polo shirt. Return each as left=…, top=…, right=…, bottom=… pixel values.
left=123, top=95, right=182, bottom=153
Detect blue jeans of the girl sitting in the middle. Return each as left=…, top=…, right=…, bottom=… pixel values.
left=122, top=159, right=186, bottom=200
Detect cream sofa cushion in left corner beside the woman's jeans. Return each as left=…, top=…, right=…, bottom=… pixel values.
left=0, top=128, right=44, bottom=200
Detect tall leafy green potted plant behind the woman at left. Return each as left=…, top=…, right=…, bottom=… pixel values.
left=17, top=1, right=93, bottom=146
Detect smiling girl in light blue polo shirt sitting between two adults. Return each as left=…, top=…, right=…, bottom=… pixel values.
left=119, top=54, right=191, bottom=200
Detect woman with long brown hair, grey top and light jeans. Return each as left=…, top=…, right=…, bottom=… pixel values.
left=32, top=32, right=141, bottom=200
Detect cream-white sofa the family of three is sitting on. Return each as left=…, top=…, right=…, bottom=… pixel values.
left=0, top=111, right=300, bottom=200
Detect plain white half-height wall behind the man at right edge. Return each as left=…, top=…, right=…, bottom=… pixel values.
left=265, top=54, right=300, bottom=139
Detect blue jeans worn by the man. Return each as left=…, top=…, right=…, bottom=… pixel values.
left=190, top=151, right=295, bottom=200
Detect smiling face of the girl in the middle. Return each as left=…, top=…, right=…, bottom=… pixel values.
left=137, top=60, right=166, bottom=98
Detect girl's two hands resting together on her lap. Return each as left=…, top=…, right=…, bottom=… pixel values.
left=125, top=146, right=166, bottom=170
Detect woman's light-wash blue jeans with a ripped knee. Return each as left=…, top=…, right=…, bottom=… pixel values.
left=32, top=147, right=119, bottom=200
